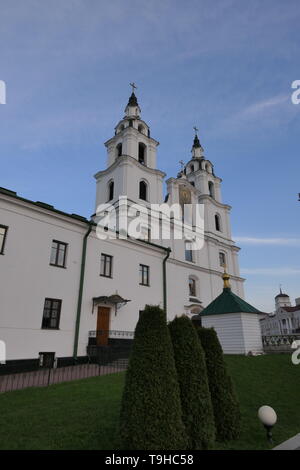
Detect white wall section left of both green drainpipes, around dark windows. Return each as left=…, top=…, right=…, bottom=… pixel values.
left=0, top=195, right=86, bottom=360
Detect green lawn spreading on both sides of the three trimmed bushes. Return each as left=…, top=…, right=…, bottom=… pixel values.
left=0, top=355, right=300, bottom=450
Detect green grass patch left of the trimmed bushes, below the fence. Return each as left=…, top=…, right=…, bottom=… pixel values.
left=0, top=373, right=124, bottom=450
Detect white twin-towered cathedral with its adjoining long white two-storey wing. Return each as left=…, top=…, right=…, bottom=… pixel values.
left=0, top=90, right=244, bottom=363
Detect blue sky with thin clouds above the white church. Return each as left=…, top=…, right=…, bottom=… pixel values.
left=0, top=0, right=300, bottom=311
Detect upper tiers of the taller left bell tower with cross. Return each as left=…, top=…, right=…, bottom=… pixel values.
left=95, top=83, right=165, bottom=209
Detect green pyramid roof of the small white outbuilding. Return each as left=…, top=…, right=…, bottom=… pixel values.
left=200, top=287, right=261, bottom=317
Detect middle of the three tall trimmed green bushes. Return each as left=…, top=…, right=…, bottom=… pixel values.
left=169, top=316, right=215, bottom=450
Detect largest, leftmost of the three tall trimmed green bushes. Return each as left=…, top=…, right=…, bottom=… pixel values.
left=120, top=305, right=187, bottom=450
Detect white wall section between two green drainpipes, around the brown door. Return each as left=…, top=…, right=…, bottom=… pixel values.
left=78, top=233, right=165, bottom=355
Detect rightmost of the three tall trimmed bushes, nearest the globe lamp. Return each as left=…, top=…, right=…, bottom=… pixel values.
left=196, top=327, right=241, bottom=442
